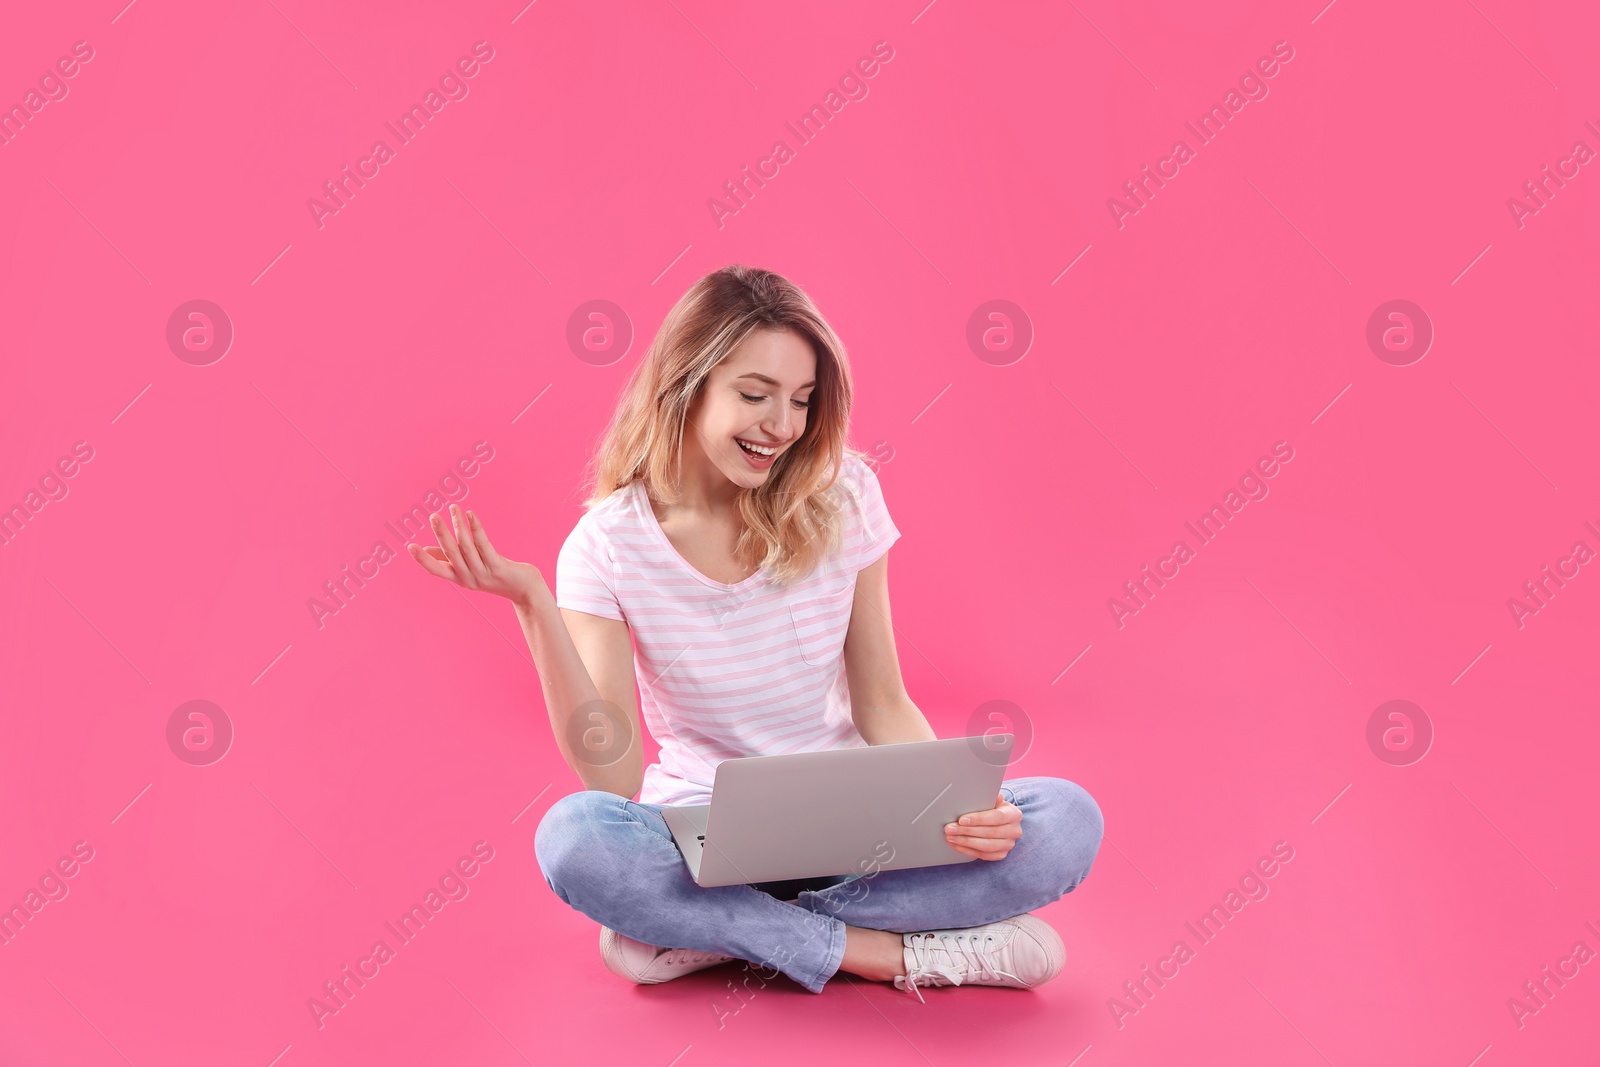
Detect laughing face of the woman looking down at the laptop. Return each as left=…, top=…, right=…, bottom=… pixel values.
left=685, top=330, right=816, bottom=488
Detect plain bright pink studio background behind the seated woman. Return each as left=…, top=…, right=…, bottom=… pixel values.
left=0, top=0, right=1600, bottom=1067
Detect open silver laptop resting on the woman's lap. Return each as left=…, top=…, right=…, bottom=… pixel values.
left=661, top=734, right=1014, bottom=888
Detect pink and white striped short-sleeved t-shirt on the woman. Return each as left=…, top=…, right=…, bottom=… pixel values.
left=555, top=454, right=899, bottom=805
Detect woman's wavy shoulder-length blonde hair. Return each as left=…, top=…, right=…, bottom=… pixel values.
left=584, top=264, right=862, bottom=584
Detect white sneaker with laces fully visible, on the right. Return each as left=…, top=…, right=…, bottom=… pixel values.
left=894, top=915, right=1067, bottom=1003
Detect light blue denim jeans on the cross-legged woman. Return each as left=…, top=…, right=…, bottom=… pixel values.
left=534, top=777, right=1106, bottom=993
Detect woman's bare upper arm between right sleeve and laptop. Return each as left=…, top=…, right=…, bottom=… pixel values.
left=845, top=552, right=938, bottom=745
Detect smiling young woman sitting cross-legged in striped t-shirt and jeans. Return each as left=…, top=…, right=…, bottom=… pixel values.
left=410, top=266, right=1104, bottom=997
